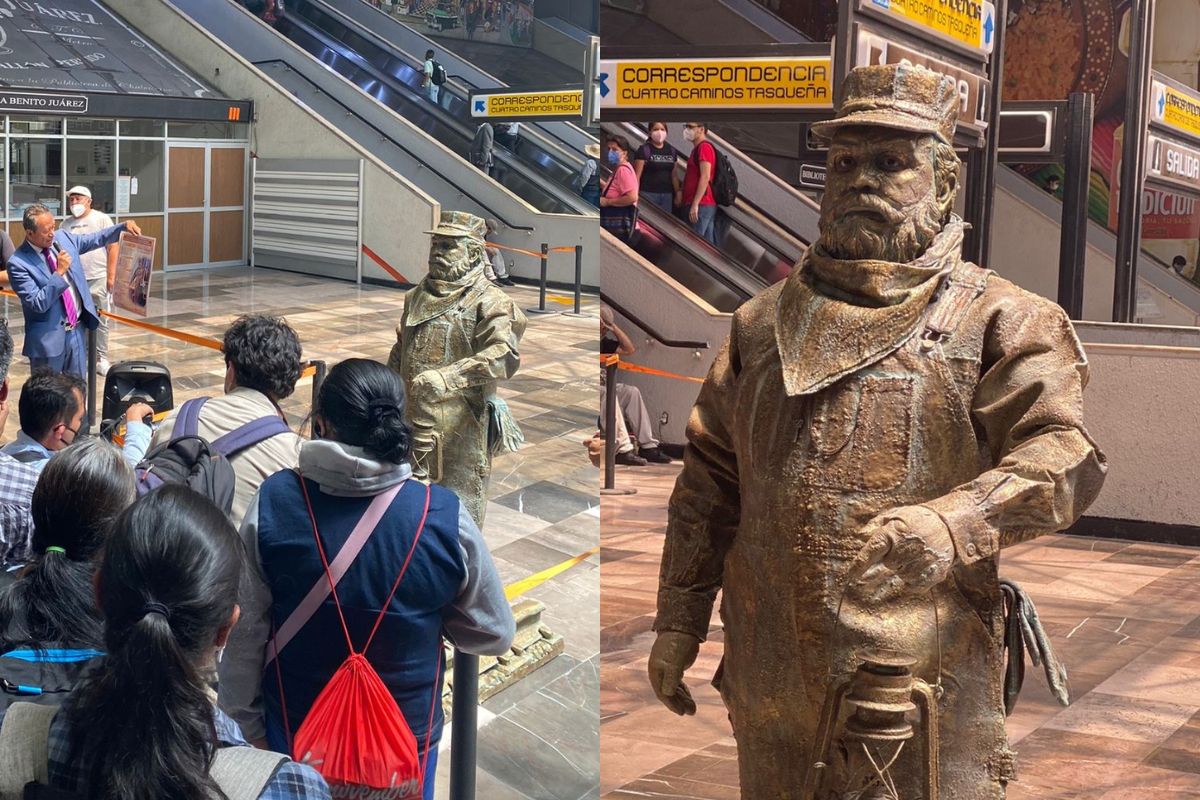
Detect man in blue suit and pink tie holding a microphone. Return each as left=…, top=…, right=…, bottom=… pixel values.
left=8, top=204, right=142, bottom=375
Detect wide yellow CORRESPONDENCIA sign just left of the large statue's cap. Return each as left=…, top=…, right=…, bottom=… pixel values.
left=600, top=55, right=833, bottom=110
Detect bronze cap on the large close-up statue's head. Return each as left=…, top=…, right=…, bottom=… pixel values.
left=812, top=64, right=960, bottom=144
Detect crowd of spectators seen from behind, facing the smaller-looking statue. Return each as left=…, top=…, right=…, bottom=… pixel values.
left=0, top=304, right=515, bottom=800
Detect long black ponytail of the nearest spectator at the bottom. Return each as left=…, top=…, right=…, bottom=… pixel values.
left=70, top=485, right=242, bottom=800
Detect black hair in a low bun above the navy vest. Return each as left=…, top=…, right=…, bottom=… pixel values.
left=313, top=359, right=413, bottom=464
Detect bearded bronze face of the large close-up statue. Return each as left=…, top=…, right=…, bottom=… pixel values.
left=820, top=127, right=956, bottom=261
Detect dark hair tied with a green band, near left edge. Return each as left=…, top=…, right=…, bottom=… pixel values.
left=0, top=439, right=134, bottom=650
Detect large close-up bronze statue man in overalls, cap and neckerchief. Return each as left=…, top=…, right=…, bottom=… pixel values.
left=649, top=66, right=1105, bottom=800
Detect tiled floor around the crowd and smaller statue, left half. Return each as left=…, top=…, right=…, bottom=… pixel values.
left=2, top=269, right=600, bottom=800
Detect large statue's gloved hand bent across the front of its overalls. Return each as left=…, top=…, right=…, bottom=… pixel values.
left=847, top=506, right=954, bottom=602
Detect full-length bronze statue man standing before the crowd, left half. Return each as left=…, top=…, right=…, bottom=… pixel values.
left=388, top=211, right=526, bottom=527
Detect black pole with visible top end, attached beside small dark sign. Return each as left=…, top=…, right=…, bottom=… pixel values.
left=1058, top=91, right=1096, bottom=319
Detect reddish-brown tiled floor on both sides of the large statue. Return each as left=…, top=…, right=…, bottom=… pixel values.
left=600, top=465, right=1200, bottom=800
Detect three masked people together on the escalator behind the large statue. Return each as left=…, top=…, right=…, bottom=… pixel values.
left=600, top=122, right=720, bottom=246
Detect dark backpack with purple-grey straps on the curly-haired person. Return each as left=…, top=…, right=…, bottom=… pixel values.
left=133, top=397, right=292, bottom=515
